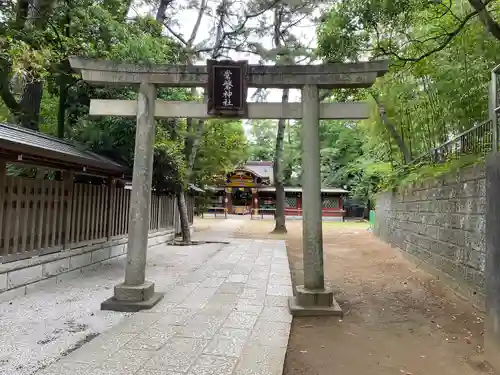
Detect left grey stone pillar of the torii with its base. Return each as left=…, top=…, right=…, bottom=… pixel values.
left=101, top=82, right=163, bottom=311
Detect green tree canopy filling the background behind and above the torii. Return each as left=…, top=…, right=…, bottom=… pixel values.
left=0, top=0, right=500, bottom=209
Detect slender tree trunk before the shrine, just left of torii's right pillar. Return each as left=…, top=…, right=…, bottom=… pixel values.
left=273, top=89, right=289, bottom=233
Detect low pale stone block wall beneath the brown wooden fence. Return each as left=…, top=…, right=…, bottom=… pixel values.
left=0, top=230, right=174, bottom=301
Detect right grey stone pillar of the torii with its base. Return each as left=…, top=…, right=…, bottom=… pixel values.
left=289, top=85, right=342, bottom=316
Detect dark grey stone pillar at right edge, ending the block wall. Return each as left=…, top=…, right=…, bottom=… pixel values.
left=484, top=152, right=500, bottom=371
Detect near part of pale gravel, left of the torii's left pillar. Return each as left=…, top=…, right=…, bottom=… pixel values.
left=0, top=260, right=126, bottom=375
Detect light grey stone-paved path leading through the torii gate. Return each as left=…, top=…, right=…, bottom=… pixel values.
left=37, top=240, right=293, bottom=375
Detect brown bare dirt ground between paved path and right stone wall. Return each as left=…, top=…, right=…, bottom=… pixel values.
left=228, top=220, right=492, bottom=375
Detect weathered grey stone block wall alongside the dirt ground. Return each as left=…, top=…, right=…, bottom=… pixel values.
left=374, top=166, right=486, bottom=300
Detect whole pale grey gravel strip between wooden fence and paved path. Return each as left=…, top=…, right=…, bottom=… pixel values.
left=0, top=231, right=228, bottom=375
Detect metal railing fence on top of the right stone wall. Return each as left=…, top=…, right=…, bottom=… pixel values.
left=411, top=119, right=494, bottom=164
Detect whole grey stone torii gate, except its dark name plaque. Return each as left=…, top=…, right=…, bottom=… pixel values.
left=70, top=57, right=388, bottom=316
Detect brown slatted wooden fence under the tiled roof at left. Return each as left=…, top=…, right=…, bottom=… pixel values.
left=0, top=176, right=193, bottom=263
